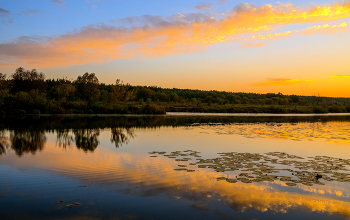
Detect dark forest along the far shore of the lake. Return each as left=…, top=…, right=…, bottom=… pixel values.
left=0, top=67, right=350, bottom=115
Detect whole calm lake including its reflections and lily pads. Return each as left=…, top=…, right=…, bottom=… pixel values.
left=0, top=115, right=350, bottom=220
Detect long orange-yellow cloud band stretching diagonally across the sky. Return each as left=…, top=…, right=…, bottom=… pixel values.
left=0, top=2, right=350, bottom=69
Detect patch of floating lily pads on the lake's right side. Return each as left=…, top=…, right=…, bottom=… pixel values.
left=149, top=150, right=350, bottom=186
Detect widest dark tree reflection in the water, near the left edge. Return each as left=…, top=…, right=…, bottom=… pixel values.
left=10, top=130, right=46, bottom=156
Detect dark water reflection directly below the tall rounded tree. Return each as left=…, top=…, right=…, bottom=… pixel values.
left=73, top=129, right=100, bottom=152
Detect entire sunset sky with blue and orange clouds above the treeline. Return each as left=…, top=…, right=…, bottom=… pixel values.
left=0, top=0, right=350, bottom=97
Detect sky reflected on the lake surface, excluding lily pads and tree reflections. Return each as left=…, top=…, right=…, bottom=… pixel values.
left=0, top=122, right=350, bottom=219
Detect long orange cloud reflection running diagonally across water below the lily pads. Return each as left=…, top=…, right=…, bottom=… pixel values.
left=5, top=142, right=350, bottom=217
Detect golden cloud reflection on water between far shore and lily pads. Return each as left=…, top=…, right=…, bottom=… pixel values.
left=196, top=122, right=350, bottom=144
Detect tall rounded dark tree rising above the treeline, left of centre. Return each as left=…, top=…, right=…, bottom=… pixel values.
left=74, top=72, right=100, bottom=105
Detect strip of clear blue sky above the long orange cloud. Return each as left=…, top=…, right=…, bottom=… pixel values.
left=0, top=0, right=338, bottom=42
